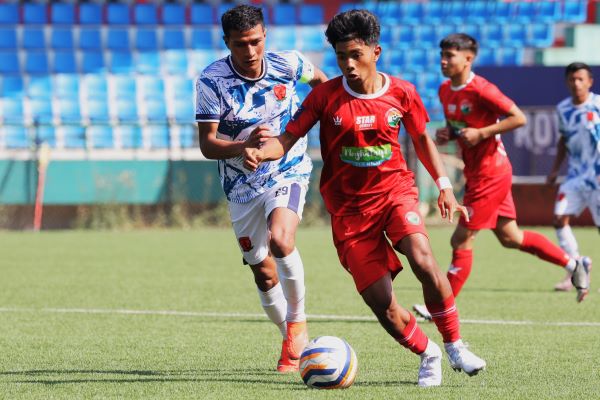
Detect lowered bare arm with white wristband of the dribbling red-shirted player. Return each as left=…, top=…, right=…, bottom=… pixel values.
left=412, top=132, right=469, bottom=222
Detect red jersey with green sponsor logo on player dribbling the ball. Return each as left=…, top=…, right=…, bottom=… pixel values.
left=286, top=74, right=429, bottom=216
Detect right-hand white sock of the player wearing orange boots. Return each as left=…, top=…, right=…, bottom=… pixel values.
left=274, top=249, right=306, bottom=322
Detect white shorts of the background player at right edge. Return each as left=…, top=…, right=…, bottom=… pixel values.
left=554, top=181, right=600, bottom=227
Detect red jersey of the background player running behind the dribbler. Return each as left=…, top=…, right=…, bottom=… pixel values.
left=439, top=74, right=515, bottom=179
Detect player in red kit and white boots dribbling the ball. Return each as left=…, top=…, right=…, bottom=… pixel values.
left=245, top=10, right=486, bottom=386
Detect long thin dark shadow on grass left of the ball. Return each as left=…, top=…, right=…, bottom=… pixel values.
left=0, top=368, right=302, bottom=386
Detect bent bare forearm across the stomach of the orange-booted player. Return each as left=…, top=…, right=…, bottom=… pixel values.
left=198, top=122, right=272, bottom=160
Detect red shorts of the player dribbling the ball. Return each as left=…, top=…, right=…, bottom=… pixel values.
left=331, top=188, right=427, bottom=293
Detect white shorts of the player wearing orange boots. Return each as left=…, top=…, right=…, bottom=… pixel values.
left=229, top=181, right=307, bottom=265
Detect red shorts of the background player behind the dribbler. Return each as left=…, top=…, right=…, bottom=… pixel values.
left=460, top=170, right=517, bottom=230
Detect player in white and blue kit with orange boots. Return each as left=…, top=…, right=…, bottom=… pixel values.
left=196, top=5, right=327, bottom=372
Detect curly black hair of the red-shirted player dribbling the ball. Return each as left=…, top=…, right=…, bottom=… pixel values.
left=325, top=10, right=380, bottom=49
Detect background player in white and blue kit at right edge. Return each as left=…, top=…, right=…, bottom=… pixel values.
left=548, top=62, right=600, bottom=291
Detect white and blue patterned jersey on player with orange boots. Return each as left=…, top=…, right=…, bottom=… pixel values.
left=196, top=51, right=314, bottom=203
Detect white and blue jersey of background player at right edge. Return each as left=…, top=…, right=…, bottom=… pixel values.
left=557, top=93, right=600, bottom=190
